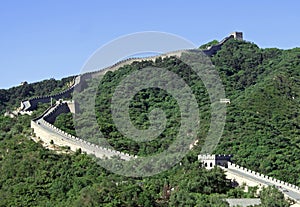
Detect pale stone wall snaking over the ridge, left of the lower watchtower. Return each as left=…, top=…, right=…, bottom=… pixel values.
left=25, top=32, right=237, bottom=160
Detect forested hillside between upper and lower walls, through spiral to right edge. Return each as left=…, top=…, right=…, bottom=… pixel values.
left=57, top=39, right=300, bottom=185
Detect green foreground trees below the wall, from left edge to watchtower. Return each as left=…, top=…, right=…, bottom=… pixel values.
left=0, top=110, right=231, bottom=206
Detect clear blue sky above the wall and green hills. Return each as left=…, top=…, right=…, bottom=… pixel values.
left=0, top=0, right=300, bottom=88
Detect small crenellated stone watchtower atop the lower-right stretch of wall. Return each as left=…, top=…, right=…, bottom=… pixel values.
left=198, top=154, right=232, bottom=169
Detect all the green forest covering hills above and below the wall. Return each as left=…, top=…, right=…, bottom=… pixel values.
left=0, top=40, right=300, bottom=207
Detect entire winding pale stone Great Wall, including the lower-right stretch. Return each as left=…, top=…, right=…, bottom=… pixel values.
left=19, top=33, right=300, bottom=202
